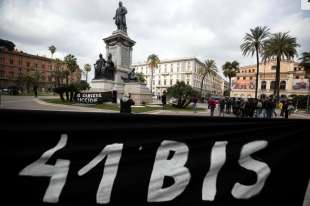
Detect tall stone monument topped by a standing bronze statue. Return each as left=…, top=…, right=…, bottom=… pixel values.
left=90, top=2, right=152, bottom=104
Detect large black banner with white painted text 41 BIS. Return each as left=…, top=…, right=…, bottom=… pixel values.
left=0, top=110, right=310, bottom=206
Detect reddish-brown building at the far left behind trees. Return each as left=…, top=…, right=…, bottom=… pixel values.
left=0, top=48, right=81, bottom=91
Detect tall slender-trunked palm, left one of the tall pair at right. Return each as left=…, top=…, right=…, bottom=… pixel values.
left=240, top=26, right=270, bottom=99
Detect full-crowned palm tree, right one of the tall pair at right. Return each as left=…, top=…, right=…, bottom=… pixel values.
left=263, top=32, right=299, bottom=101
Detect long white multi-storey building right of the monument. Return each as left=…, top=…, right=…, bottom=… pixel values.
left=132, top=58, right=225, bottom=96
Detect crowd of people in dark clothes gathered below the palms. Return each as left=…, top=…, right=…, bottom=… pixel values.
left=207, top=96, right=295, bottom=119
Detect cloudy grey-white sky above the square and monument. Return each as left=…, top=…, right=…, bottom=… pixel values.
left=0, top=0, right=310, bottom=79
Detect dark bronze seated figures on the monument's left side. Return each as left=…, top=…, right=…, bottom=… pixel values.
left=94, top=54, right=115, bottom=80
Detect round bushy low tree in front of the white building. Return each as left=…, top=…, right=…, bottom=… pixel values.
left=167, top=81, right=199, bottom=108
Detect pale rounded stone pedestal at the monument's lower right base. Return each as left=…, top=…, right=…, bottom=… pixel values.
left=124, top=82, right=152, bottom=105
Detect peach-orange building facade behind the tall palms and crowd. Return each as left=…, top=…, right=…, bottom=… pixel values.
left=230, top=61, right=309, bottom=98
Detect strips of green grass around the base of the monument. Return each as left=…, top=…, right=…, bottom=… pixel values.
left=41, top=99, right=205, bottom=113
